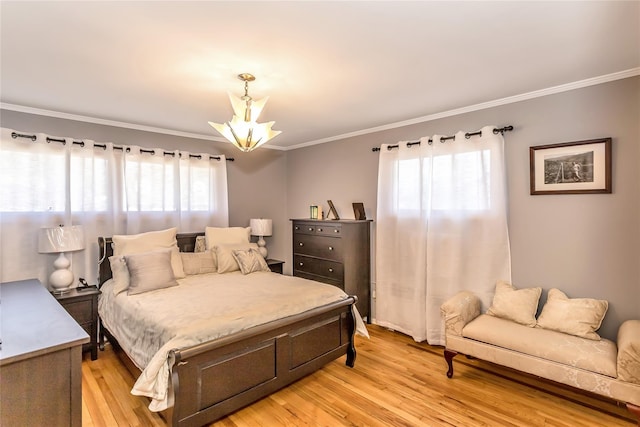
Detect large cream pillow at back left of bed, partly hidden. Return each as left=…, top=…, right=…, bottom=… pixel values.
left=112, top=227, right=185, bottom=279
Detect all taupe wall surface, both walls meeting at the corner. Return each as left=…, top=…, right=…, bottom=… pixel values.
left=0, top=77, right=640, bottom=338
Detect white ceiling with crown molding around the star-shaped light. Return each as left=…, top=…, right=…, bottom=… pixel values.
left=0, top=1, right=640, bottom=149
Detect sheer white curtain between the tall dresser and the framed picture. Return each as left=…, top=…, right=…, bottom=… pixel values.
left=375, top=126, right=511, bottom=345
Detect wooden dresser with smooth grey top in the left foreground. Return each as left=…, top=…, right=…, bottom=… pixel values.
left=0, top=279, right=89, bottom=427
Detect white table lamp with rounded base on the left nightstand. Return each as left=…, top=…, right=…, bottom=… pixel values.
left=38, top=225, right=84, bottom=293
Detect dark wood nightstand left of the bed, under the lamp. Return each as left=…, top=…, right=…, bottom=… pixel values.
left=53, top=286, right=100, bottom=360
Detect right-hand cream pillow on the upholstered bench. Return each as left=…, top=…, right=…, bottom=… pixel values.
left=537, top=289, right=609, bottom=341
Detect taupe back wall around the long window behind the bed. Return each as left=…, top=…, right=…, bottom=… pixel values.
left=0, top=110, right=289, bottom=259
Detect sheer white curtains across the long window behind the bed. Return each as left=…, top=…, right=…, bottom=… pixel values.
left=0, top=128, right=229, bottom=284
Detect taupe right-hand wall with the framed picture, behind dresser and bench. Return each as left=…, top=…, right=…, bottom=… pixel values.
left=286, top=77, right=640, bottom=338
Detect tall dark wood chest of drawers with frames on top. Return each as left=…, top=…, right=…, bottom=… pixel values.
left=291, top=219, right=371, bottom=322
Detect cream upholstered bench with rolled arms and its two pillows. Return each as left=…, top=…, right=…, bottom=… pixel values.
left=441, top=282, right=640, bottom=426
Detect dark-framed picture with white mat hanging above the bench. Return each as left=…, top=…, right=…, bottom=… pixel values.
left=529, top=138, right=611, bottom=195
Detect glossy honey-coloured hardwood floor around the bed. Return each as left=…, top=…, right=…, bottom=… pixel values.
left=82, top=325, right=635, bottom=427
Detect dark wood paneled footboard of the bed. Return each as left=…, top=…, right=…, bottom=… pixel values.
left=165, top=298, right=356, bottom=426
